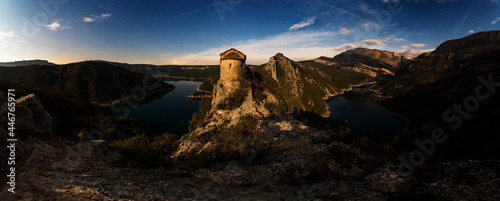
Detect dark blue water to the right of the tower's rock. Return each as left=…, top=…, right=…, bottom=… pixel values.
left=328, top=96, right=406, bottom=141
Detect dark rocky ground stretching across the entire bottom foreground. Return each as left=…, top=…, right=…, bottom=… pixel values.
left=0, top=125, right=500, bottom=200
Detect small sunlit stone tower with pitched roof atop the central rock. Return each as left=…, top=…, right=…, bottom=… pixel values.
left=220, top=48, right=247, bottom=82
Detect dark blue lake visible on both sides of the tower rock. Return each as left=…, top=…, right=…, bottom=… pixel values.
left=111, top=80, right=405, bottom=141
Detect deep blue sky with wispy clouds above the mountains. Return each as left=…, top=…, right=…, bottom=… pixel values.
left=0, top=0, right=500, bottom=65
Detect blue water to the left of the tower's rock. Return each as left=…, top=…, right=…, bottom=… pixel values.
left=110, top=81, right=201, bottom=135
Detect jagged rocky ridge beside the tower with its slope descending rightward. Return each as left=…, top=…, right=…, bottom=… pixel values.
left=253, top=53, right=374, bottom=116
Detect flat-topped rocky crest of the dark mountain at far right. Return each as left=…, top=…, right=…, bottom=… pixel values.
left=432, top=31, right=500, bottom=54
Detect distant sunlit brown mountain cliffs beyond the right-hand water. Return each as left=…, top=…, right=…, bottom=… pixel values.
left=315, top=48, right=410, bottom=77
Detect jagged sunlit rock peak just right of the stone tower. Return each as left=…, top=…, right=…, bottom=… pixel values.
left=260, top=53, right=343, bottom=117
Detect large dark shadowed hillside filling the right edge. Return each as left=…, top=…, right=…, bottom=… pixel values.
left=381, top=31, right=500, bottom=160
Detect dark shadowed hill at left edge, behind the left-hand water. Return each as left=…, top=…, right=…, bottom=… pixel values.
left=0, top=61, right=173, bottom=104
